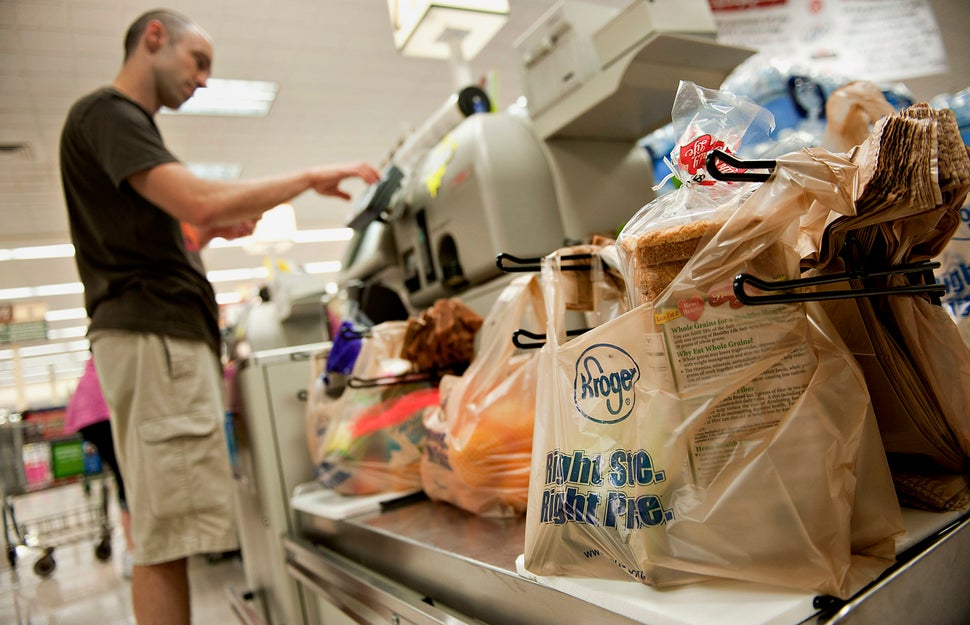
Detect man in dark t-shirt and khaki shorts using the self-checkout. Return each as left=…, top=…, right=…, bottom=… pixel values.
left=60, top=10, right=379, bottom=625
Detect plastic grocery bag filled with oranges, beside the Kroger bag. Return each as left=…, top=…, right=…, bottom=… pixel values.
left=421, top=275, right=545, bottom=517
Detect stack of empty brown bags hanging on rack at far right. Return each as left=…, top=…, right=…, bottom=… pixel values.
left=803, top=104, right=970, bottom=510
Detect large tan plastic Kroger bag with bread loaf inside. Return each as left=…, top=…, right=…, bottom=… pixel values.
left=525, top=151, right=902, bottom=598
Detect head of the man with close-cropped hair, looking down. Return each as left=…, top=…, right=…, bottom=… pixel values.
left=125, top=9, right=212, bottom=109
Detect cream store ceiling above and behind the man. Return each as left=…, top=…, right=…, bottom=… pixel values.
left=0, top=0, right=970, bottom=407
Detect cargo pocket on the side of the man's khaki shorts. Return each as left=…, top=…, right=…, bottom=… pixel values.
left=138, top=413, right=231, bottom=519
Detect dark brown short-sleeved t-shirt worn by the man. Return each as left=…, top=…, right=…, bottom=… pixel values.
left=60, top=88, right=220, bottom=355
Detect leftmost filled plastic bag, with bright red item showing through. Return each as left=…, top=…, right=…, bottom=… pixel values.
left=313, top=321, right=438, bottom=495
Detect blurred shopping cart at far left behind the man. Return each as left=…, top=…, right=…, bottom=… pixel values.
left=0, top=415, right=111, bottom=577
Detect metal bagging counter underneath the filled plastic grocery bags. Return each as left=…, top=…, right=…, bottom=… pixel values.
left=283, top=495, right=970, bottom=625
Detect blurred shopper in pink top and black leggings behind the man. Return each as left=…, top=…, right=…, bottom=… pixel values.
left=64, top=357, right=135, bottom=579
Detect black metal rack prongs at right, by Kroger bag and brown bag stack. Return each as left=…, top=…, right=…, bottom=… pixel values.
left=705, top=150, right=946, bottom=306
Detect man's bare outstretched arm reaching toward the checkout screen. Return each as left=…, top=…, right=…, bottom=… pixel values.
left=128, top=162, right=380, bottom=229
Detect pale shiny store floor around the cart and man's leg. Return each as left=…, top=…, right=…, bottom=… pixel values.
left=0, top=476, right=245, bottom=625
